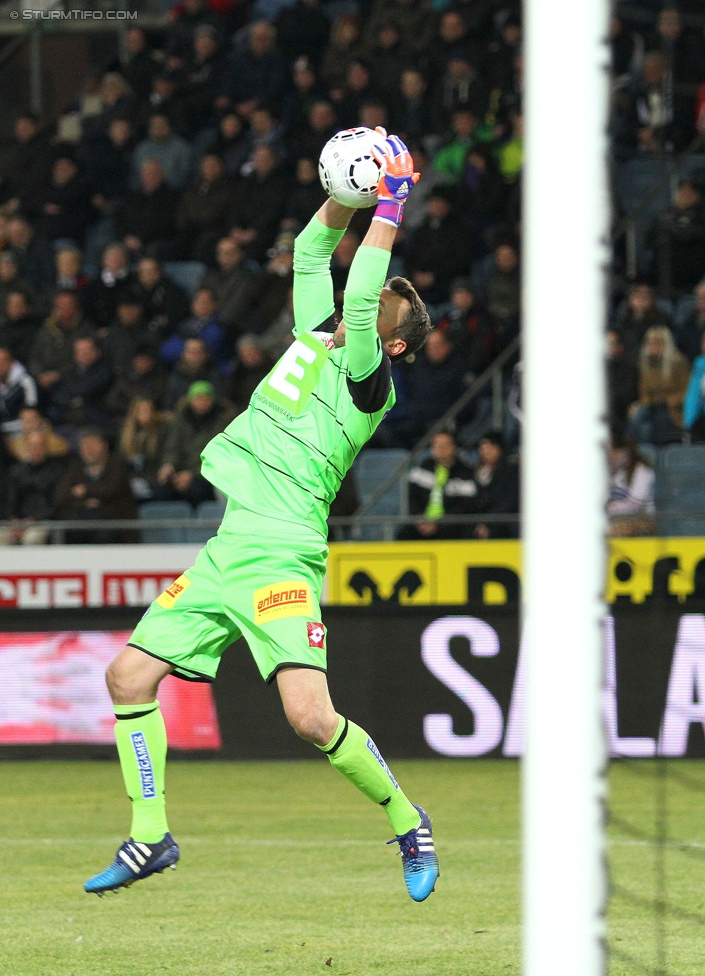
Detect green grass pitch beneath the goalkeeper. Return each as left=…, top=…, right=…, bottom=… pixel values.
left=0, top=761, right=705, bottom=976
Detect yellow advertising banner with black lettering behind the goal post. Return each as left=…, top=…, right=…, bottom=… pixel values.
left=328, top=533, right=705, bottom=607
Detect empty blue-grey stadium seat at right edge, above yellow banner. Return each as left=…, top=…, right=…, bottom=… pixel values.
left=656, top=444, right=705, bottom=536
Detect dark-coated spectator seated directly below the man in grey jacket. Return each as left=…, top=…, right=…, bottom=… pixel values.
left=115, top=159, right=178, bottom=259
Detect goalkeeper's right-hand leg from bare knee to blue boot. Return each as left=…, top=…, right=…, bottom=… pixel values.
left=277, top=667, right=439, bottom=901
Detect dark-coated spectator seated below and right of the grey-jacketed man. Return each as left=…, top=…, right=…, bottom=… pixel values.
left=176, top=153, right=235, bottom=264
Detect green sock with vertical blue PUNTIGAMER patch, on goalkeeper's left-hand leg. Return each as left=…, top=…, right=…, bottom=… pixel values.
left=115, top=701, right=169, bottom=844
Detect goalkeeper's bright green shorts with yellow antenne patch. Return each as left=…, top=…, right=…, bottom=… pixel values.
left=128, top=502, right=328, bottom=682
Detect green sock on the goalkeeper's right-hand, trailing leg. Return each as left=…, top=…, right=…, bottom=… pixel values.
left=318, top=715, right=421, bottom=834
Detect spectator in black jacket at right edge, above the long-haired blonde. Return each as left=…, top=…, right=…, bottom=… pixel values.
left=648, top=174, right=705, bottom=294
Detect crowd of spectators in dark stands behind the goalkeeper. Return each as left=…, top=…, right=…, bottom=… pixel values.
left=0, top=0, right=705, bottom=542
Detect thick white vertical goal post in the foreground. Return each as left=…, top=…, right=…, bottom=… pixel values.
left=522, top=0, right=609, bottom=976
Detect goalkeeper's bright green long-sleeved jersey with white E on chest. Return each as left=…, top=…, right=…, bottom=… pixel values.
left=202, top=217, right=395, bottom=536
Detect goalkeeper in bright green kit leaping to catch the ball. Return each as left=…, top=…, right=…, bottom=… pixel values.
left=85, top=130, right=438, bottom=901
